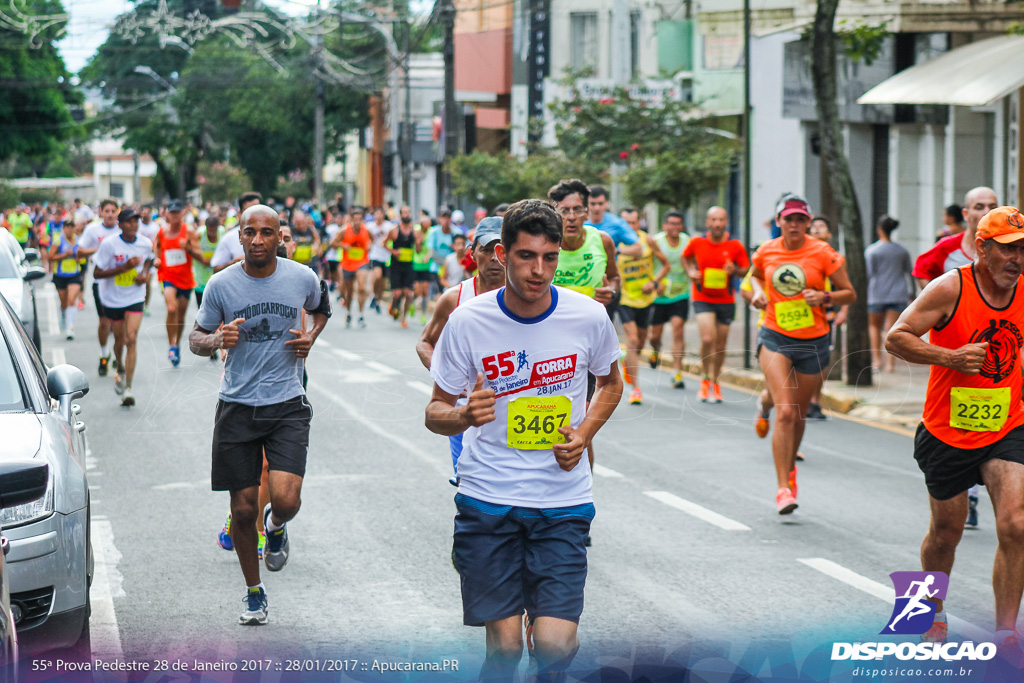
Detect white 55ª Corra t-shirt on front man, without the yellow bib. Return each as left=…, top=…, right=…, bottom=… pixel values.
left=430, top=287, right=621, bottom=508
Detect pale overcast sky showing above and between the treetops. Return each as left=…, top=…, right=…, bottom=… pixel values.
left=59, top=0, right=423, bottom=74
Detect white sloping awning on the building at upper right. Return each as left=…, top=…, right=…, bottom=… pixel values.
left=857, top=36, right=1024, bottom=106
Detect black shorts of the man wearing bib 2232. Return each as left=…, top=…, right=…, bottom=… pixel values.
left=913, top=422, right=1024, bottom=501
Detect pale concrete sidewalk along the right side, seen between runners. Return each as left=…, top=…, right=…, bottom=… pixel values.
left=643, top=306, right=929, bottom=429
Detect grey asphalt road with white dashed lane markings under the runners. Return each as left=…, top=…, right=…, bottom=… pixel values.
left=24, top=280, right=995, bottom=680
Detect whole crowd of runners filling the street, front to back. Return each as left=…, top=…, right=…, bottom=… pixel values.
left=4, top=184, right=1024, bottom=680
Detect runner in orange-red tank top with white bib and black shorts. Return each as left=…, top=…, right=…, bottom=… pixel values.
left=156, top=200, right=203, bottom=368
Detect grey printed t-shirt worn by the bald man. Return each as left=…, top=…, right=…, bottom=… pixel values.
left=196, top=258, right=321, bottom=405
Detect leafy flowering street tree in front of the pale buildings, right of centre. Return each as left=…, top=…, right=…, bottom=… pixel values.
left=551, top=78, right=738, bottom=208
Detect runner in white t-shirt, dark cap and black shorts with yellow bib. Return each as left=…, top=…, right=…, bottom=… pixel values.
left=92, top=209, right=155, bottom=407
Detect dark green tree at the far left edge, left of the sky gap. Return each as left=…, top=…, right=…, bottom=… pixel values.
left=0, top=0, right=82, bottom=166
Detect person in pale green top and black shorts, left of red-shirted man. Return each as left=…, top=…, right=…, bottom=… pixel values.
left=650, top=211, right=690, bottom=389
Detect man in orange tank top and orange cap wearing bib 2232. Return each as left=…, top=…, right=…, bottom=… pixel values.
left=886, top=207, right=1024, bottom=651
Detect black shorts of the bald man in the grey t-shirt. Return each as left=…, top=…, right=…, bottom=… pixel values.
left=210, top=395, right=313, bottom=490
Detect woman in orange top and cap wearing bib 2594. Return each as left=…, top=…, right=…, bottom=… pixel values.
left=751, top=195, right=857, bottom=515
